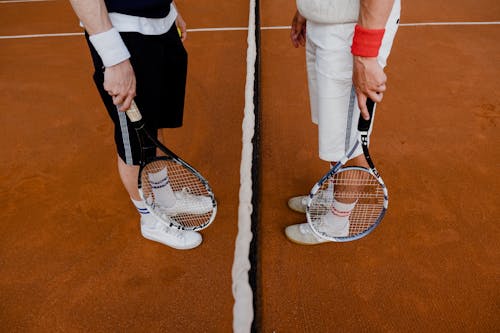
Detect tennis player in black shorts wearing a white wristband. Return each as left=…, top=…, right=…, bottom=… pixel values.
left=70, top=0, right=202, bottom=249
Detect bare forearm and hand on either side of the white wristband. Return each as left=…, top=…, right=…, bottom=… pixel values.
left=70, top=0, right=136, bottom=111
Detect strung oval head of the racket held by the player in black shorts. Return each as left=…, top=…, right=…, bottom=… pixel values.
left=141, top=159, right=215, bottom=229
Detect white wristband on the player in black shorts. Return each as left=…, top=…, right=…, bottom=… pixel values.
left=89, top=28, right=130, bottom=67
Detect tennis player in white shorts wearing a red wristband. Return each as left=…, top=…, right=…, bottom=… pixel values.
left=285, top=0, right=401, bottom=245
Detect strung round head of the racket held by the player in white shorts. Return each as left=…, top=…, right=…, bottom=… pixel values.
left=309, top=168, right=387, bottom=238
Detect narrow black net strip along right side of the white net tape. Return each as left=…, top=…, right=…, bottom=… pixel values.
left=249, top=0, right=262, bottom=333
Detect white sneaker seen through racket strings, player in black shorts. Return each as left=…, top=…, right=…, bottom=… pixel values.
left=148, top=188, right=213, bottom=216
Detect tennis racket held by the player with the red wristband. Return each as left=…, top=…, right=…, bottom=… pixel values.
left=306, top=100, right=389, bottom=242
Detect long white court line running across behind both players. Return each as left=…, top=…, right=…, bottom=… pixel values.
left=0, top=21, right=500, bottom=39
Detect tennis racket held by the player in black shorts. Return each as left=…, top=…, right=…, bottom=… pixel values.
left=126, top=102, right=217, bottom=230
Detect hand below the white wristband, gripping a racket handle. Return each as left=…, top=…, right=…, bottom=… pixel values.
left=104, top=59, right=136, bottom=111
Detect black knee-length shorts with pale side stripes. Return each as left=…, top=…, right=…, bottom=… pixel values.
left=87, top=24, right=187, bottom=165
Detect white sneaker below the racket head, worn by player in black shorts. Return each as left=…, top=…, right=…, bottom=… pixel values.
left=141, top=215, right=202, bottom=250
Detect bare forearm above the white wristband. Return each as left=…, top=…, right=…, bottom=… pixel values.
left=70, top=0, right=113, bottom=35
